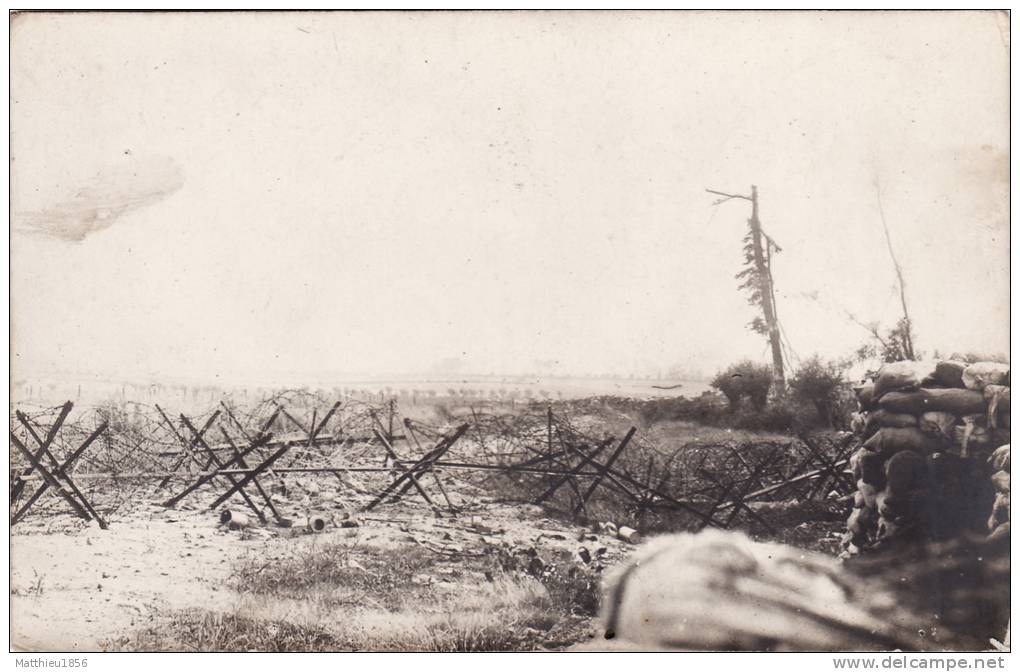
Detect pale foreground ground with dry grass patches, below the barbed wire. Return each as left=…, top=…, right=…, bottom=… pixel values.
left=10, top=409, right=846, bottom=651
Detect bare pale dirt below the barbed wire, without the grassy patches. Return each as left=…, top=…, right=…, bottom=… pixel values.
left=10, top=485, right=633, bottom=651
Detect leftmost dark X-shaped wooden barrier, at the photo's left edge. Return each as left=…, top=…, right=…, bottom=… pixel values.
left=10, top=402, right=108, bottom=529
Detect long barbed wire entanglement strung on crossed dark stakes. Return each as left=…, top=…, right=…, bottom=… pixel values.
left=10, top=390, right=856, bottom=529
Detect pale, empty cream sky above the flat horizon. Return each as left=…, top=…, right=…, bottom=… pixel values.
left=11, top=12, right=1010, bottom=381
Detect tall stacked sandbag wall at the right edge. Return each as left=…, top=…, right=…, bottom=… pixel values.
left=844, top=360, right=1010, bottom=555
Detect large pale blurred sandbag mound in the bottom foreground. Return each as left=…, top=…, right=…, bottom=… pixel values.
left=602, top=530, right=934, bottom=651
